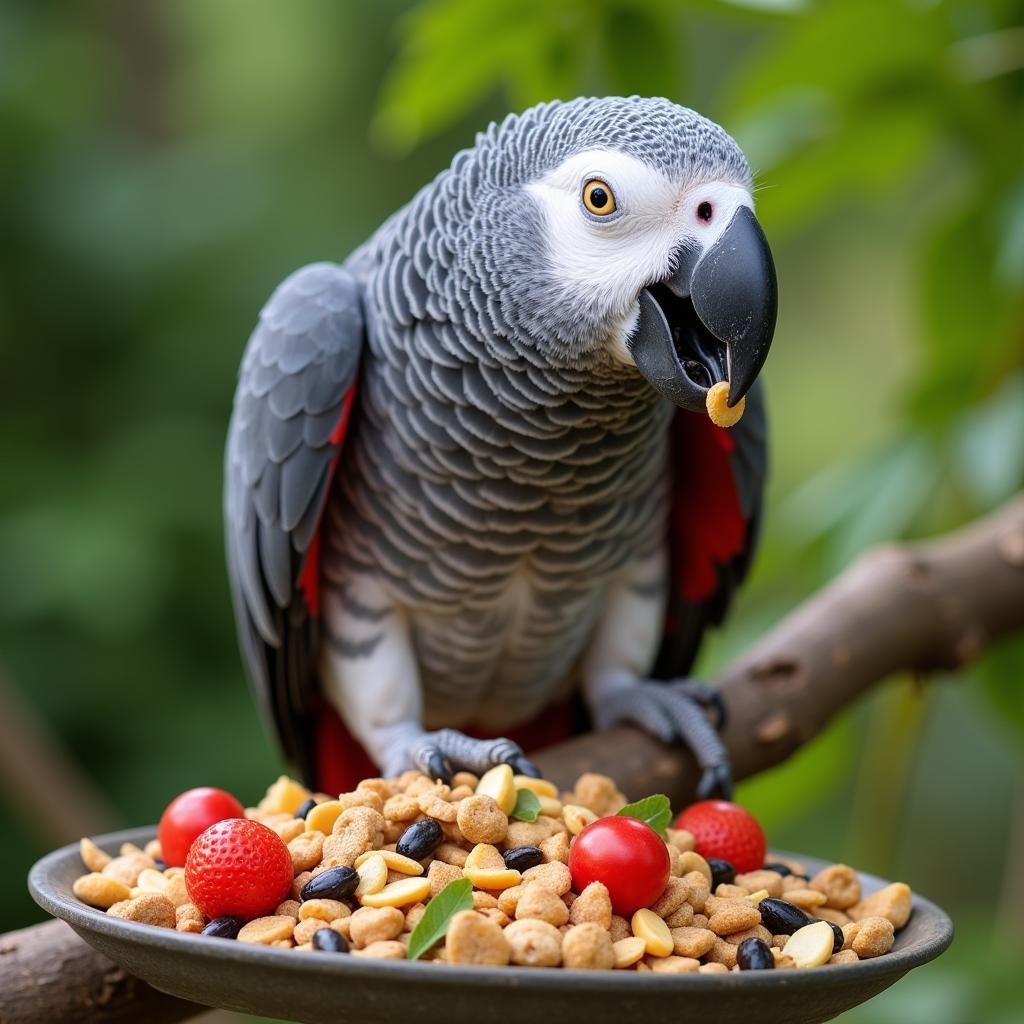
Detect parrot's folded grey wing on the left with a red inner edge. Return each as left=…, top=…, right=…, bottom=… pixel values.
left=224, top=263, right=365, bottom=777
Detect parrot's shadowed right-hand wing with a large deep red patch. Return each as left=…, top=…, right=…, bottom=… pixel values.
left=653, top=382, right=768, bottom=679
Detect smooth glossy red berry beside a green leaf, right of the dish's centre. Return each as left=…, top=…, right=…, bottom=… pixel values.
left=569, top=815, right=672, bottom=918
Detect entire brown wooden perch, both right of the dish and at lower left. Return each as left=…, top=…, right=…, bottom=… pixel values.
left=8, top=497, right=1024, bottom=1024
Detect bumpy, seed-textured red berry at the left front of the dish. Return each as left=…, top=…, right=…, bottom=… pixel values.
left=185, top=818, right=293, bottom=921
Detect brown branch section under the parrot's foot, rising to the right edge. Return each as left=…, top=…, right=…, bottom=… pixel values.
left=535, top=497, right=1024, bottom=803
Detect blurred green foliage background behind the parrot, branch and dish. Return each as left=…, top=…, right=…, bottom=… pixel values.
left=0, top=0, right=1024, bottom=1024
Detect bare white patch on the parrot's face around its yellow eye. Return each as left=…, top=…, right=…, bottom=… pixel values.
left=526, top=150, right=754, bottom=362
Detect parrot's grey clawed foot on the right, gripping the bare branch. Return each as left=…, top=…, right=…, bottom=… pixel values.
left=597, top=679, right=732, bottom=800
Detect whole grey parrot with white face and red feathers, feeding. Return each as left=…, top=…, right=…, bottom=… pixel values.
left=224, top=96, right=776, bottom=793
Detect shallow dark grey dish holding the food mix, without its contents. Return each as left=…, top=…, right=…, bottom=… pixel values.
left=29, top=828, right=953, bottom=1024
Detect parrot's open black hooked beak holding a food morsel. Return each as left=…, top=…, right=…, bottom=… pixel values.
left=627, top=206, right=778, bottom=412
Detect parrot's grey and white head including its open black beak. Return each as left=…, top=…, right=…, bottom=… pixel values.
left=473, top=96, right=777, bottom=411
